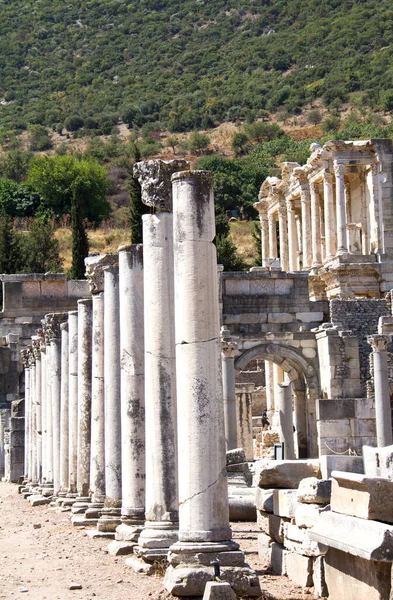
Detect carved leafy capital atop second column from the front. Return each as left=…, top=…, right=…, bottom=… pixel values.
left=134, top=159, right=190, bottom=212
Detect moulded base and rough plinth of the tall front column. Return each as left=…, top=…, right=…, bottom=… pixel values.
left=164, top=540, right=261, bottom=597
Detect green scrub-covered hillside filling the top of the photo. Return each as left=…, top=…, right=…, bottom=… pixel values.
left=0, top=0, right=393, bottom=133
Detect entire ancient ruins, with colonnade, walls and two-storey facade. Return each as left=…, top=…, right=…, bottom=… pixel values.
left=0, top=139, right=393, bottom=600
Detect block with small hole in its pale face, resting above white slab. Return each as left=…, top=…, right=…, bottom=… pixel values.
left=331, top=471, right=393, bottom=523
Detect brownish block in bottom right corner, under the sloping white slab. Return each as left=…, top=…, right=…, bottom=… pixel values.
left=325, top=548, right=391, bottom=600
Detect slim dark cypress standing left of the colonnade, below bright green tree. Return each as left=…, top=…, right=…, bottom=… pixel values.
left=69, top=190, right=89, bottom=279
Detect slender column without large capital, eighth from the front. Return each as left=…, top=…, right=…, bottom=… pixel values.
left=60, top=322, right=70, bottom=496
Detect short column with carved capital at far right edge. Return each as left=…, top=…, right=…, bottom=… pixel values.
left=367, top=335, right=393, bottom=447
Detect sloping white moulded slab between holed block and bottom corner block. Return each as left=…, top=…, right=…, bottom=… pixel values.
left=309, top=511, right=393, bottom=562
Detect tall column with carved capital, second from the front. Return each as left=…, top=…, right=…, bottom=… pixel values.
left=130, top=160, right=187, bottom=562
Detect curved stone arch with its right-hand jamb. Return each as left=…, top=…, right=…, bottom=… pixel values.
left=235, top=342, right=319, bottom=457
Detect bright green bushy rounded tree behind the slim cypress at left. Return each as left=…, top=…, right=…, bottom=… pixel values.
left=27, top=155, right=110, bottom=223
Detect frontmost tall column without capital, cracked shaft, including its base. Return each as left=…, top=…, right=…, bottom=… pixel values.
left=164, top=171, right=259, bottom=596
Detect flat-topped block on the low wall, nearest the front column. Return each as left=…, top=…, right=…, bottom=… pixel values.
left=255, top=459, right=320, bottom=489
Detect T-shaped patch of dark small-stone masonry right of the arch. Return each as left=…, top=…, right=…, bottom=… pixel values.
left=329, top=299, right=390, bottom=394
